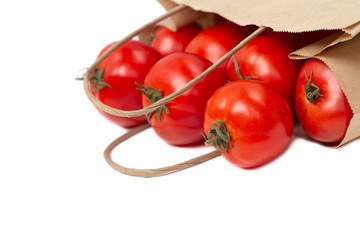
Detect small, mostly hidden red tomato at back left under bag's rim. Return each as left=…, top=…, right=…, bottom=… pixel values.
left=151, top=23, right=202, bottom=56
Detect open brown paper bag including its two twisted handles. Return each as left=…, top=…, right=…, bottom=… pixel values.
left=84, top=0, right=360, bottom=177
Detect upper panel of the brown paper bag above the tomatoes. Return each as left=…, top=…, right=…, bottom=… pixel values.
left=158, top=0, right=360, bottom=36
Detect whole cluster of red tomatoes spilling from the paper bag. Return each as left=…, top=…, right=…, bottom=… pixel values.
left=90, top=17, right=352, bottom=168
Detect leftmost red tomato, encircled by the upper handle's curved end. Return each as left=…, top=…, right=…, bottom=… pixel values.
left=91, top=40, right=162, bottom=128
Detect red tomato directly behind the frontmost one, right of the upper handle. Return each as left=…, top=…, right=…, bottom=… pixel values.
left=226, top=36, right=303, bottom=112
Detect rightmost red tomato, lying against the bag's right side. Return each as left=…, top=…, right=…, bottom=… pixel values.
left=295, top=59, right=353, bottom=143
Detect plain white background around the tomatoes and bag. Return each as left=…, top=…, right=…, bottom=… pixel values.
left=0, top=0, right=360, bottom=240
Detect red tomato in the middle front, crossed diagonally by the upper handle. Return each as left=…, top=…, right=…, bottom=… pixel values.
left=142, top=53, right=226, bottom=145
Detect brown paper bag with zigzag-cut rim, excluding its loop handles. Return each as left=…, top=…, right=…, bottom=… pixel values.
left=158, top=0, right=360, bottom=146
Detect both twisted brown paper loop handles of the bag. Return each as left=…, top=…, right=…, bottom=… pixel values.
left=84, top=5, right=267, bottom=177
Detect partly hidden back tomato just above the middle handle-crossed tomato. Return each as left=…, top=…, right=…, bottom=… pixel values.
left=185, top=24, right=245, bottom=72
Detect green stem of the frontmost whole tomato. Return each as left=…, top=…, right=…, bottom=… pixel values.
left=202, top=120, right=230, bottom=152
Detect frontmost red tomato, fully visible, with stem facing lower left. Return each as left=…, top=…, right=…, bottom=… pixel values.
left=204, top=80, right=294, bottom=168
